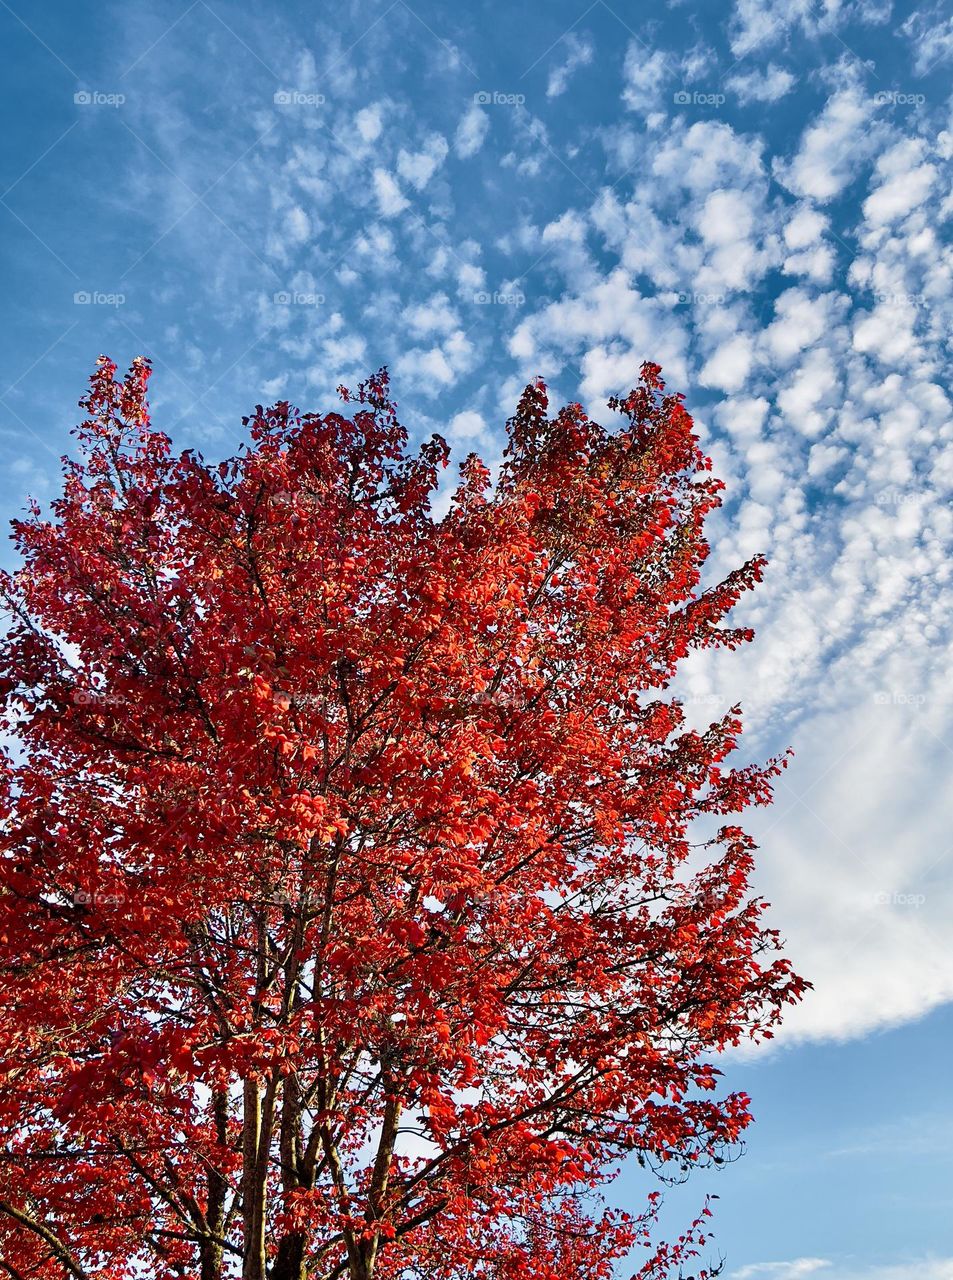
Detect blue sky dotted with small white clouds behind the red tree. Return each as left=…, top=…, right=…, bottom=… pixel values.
left=0, top=0, right=953, bottom=1280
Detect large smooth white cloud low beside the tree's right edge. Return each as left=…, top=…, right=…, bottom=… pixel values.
left=726, top=696, right=953, bottom=1042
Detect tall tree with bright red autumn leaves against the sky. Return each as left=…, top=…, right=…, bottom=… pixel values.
left=0, top=357, right=803, bottom=1280
